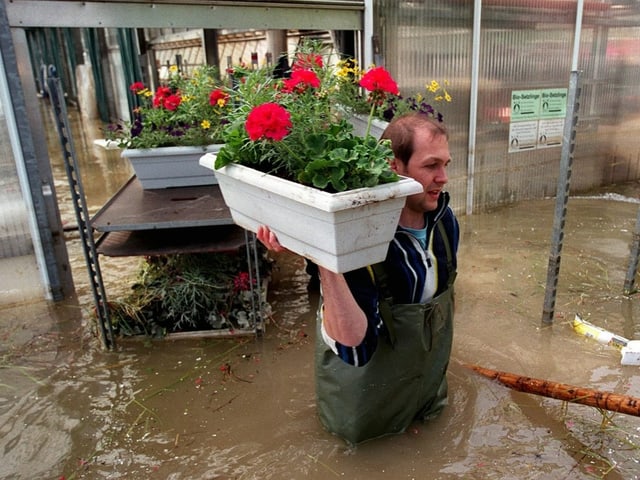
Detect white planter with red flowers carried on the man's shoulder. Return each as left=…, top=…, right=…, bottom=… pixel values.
left=200, top=44, right=422, bottom=272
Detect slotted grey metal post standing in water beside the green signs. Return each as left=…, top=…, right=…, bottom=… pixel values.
left=542, top=71, right=580, bottom=324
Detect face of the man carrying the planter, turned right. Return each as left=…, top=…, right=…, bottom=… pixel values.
left=391, top=128, right=451, bottom=214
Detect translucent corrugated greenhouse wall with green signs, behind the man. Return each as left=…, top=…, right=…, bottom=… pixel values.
left=374, top=0, right=640, bottom=213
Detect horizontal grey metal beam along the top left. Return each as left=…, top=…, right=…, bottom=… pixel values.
left=3, top=0, right=364, bottom=30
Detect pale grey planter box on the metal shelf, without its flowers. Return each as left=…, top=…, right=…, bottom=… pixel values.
left=121, top=145, right=222, bottom=190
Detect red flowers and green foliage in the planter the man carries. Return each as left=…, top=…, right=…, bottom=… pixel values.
left=215, top=40, right=398, bottom=192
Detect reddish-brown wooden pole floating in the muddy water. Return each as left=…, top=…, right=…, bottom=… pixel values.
left=464, top=364, right=640, bottom=417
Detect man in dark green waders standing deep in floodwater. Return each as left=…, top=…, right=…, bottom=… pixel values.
left=257, top=114, right=459, bottom=444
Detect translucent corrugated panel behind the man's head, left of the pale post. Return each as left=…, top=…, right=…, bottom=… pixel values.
left=374, top=0, right=473, bottom=214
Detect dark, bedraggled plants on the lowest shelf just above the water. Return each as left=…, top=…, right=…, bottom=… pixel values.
left=110, top=252, right=269, bottom=337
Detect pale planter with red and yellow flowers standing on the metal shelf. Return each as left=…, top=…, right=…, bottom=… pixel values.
left=106, top=65, right=229, bottom=189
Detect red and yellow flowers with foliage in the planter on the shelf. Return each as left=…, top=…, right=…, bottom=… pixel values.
left=106, top=65, right=229, bottom=149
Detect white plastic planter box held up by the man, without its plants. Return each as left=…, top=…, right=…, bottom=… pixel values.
left=200, top=154, right=423, bottom=273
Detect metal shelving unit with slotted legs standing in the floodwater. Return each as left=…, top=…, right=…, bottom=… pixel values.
left=48, top=69, right=264, bottom=349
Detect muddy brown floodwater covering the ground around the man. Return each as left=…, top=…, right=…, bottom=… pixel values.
left=0, top=104, right=640, bottom=480
